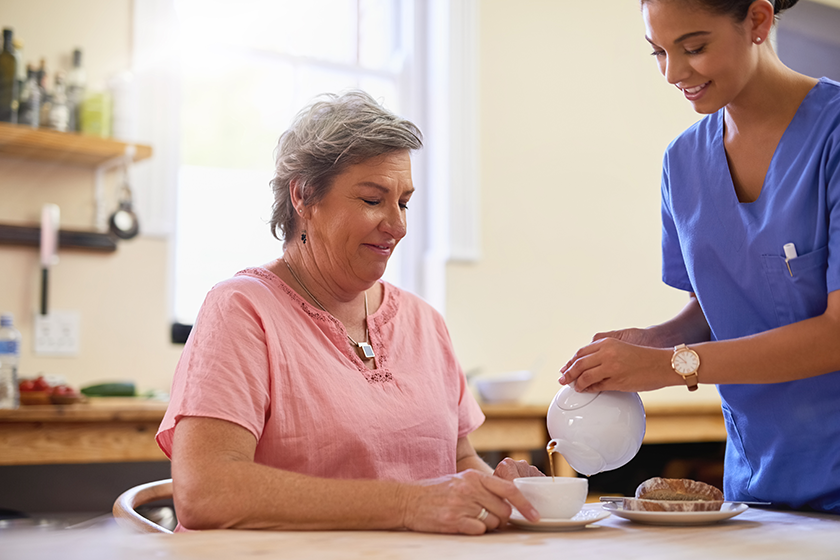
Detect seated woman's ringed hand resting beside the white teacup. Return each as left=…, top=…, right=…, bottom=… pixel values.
left=403, top=469, right=539, bottom=535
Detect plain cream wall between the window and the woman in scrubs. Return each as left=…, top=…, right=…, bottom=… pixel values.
left=447, top=0, right=698, bottom=403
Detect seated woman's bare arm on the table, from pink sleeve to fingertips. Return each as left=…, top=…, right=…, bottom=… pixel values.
left=172, top=417, right=539, bottom=534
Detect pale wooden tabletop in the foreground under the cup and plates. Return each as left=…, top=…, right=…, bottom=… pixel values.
left=3, top=508, right=840, bottom=560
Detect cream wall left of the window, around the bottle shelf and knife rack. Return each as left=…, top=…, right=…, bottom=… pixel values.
left=0, top=0, right=181, bottom=390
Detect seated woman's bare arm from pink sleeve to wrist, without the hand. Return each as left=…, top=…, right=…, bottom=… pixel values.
left=172, top=417, right=412, bottom=530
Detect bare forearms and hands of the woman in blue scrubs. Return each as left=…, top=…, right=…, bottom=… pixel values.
left=559, top=291, right=840, bottom=391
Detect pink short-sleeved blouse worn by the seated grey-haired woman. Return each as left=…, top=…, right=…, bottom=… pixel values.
left=157, top=268, right=484, bottom=481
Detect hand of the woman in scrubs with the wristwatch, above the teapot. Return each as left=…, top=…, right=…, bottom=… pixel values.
left=558, top=336, right=680, bottom=392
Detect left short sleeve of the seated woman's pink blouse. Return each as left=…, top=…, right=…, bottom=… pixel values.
left=157, top=277, right=270, bottom=457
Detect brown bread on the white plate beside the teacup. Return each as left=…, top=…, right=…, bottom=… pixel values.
left=624, top=477, right=723, bottom=511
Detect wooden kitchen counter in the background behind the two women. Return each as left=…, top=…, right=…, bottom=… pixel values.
left=0, top=389, right=726, bottom=470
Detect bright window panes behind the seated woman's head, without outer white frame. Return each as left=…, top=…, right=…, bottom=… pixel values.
left=174, top=0, right=412, bottom=323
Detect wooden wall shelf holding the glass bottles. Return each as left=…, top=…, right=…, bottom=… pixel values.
left=0, top=123, right=152, bottom=168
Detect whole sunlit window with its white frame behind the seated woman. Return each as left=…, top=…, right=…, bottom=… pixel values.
left=133, top=0, right=478, bottom=332
